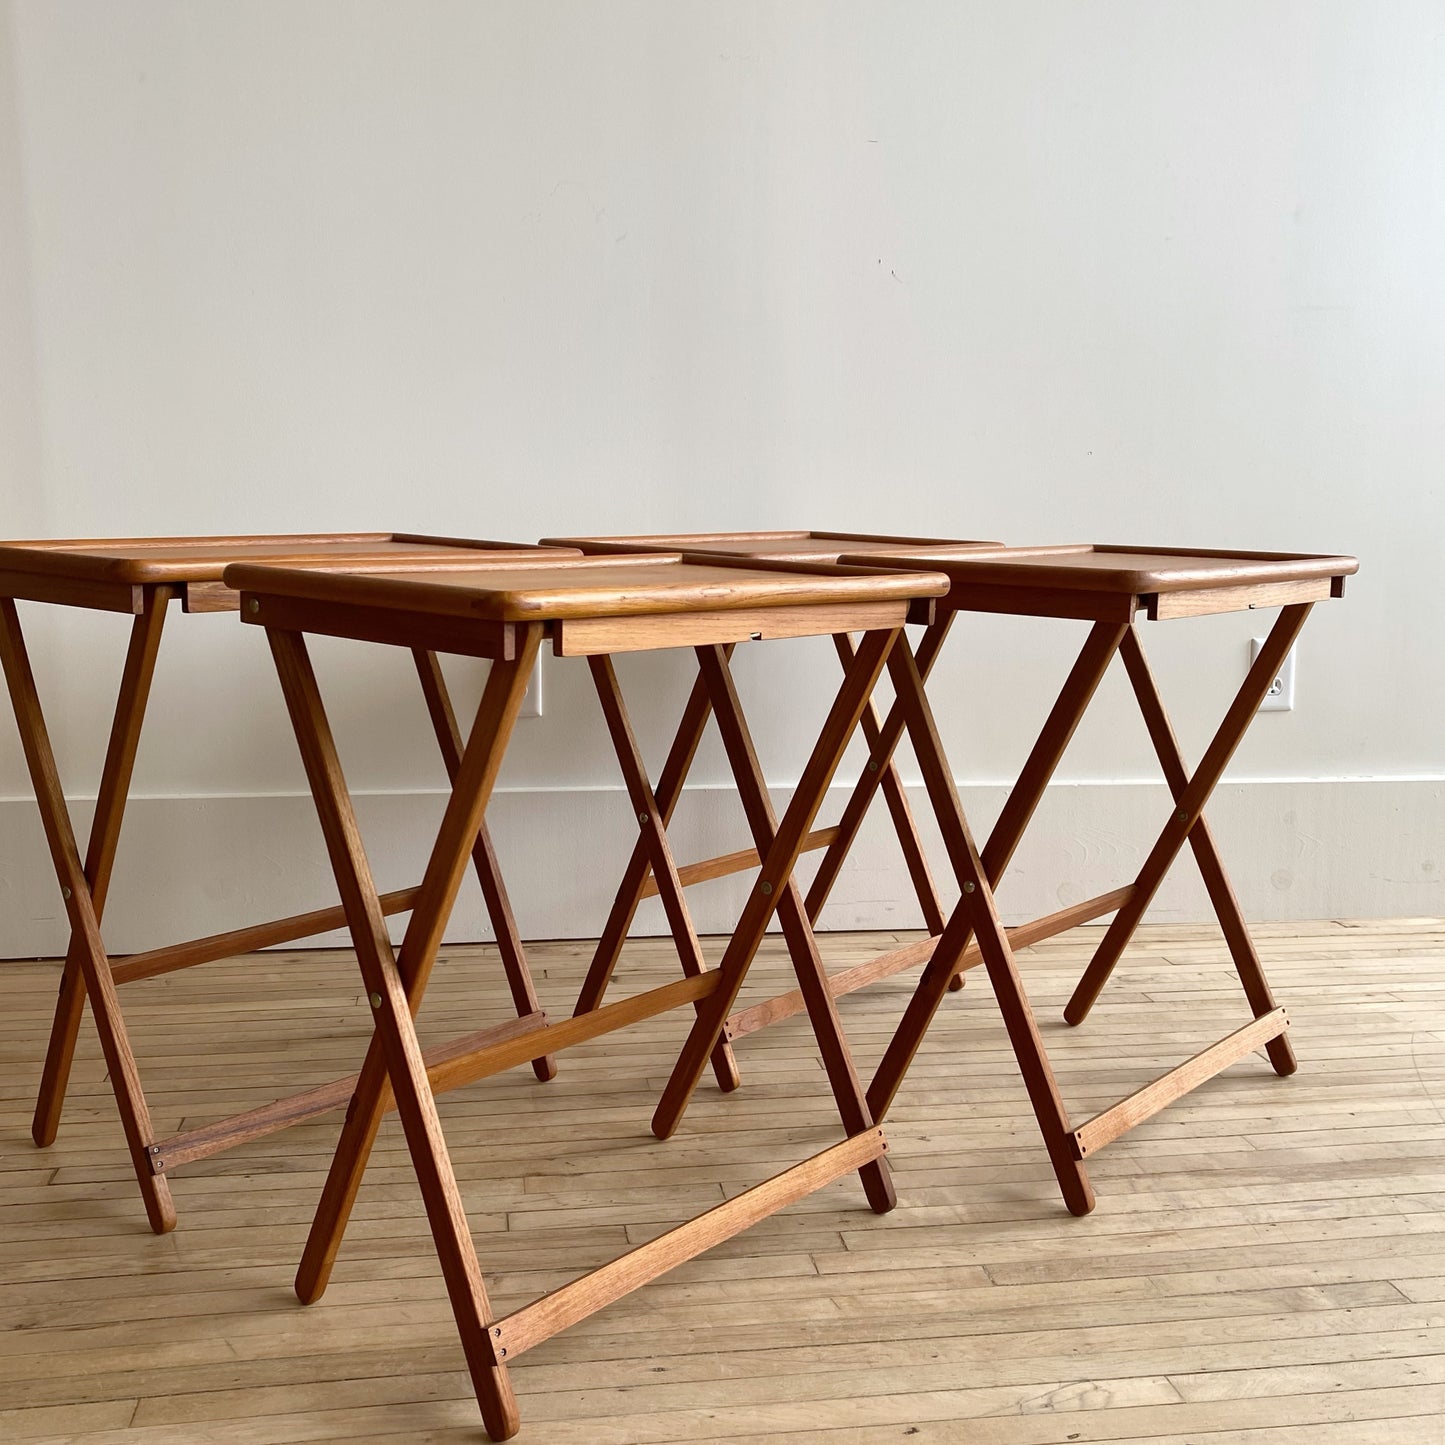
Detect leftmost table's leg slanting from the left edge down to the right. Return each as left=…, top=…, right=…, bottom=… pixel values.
left=0, top=598, right=176, bottom=1234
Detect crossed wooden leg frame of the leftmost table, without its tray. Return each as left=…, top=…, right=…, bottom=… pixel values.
left=0, top=587, right=556, bottom=1234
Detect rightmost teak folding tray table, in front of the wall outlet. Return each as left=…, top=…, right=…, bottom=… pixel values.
left=687, top=546, right=1358, bottom=1214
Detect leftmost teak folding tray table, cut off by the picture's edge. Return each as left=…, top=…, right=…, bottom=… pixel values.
left=0, top=532, right=572, bottom=1234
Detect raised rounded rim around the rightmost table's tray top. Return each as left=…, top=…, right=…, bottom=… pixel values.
left=841, top=542, right=1360, bottom=595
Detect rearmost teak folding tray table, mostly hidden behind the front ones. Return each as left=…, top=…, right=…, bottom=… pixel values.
left=542, top=532, right=1000, bottom=1090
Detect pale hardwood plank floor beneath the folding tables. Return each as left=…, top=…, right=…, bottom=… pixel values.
left=0, top=919, right=1445, bottom=1445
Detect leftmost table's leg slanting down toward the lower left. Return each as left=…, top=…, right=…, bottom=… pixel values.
left=30, top=587, right=172, bottom=1149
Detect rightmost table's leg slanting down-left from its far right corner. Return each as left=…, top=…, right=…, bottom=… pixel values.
left=1064, top=603, right=1312, bottom=1025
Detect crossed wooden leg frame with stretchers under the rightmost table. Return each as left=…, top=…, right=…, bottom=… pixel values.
left=843, top=604, right=1309, bottom=1214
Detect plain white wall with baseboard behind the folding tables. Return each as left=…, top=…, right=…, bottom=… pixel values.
left=0, top=0, right=1445, bottom=955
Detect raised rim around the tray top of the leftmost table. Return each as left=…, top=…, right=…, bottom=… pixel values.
left=0, top=532, right=551, bottom=585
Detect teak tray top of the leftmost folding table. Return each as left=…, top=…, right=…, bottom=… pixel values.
left=0, top=532, right=557, bottom=585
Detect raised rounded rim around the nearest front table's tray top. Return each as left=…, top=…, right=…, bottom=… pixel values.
left=225, top=552, right=949, bottom=623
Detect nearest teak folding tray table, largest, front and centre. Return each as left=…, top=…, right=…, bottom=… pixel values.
left=225, top=553, right=948, bottom=1439
